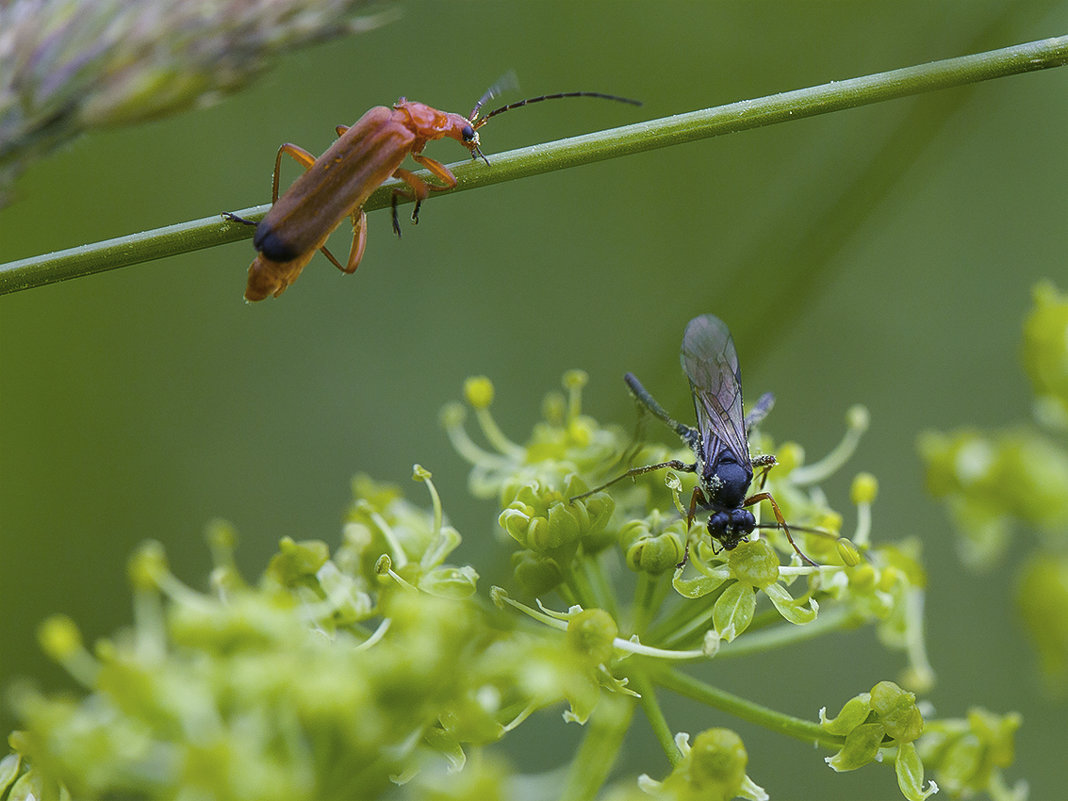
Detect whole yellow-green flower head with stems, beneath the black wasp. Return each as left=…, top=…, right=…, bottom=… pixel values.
left=6, top=372, right=1019, bottom=801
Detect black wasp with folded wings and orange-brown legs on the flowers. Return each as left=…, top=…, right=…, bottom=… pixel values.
left=572, top=314, right=816, bottom=565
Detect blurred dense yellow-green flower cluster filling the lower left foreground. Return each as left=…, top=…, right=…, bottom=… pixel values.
left=0, top=468, right=611, bottom=801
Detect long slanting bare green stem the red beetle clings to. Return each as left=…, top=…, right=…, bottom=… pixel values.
left=0, top=36, right=1068, bottom=294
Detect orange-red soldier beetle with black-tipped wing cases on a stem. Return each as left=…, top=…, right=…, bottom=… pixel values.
left=223, top=74, right=641, bottom=301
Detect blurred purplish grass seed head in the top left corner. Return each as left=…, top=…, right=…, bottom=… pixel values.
left=0, top=0, right=392, bottom=206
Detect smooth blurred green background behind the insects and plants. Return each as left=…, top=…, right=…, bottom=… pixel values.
left=0, top=1, right=1068, bottom=799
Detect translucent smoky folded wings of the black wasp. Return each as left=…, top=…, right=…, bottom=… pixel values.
left=679, top=314, right=752, bottom=469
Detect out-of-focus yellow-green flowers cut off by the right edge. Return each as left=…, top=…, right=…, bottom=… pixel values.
left=920, top=282, right=1068, bottom=694
